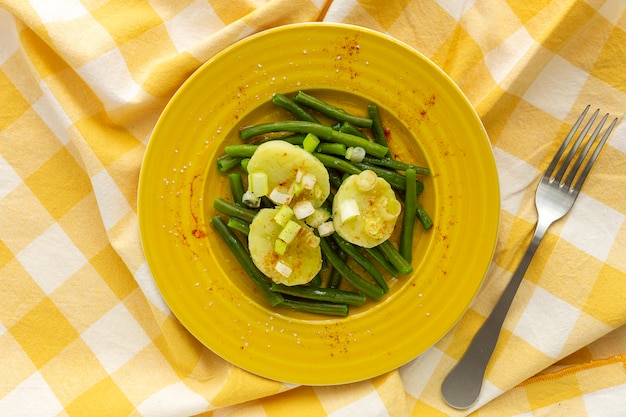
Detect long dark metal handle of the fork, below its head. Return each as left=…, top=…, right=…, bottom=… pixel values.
left=441, top=223, right=547, bottom=409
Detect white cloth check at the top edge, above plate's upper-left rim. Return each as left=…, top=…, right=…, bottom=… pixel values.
left=165, top=0, right=224, bottom=56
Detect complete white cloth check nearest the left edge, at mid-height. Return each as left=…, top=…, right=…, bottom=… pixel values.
left=17, top=223, right=87, bottom=294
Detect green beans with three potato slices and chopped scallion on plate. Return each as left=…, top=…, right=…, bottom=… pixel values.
left=211, top=91, right=432, bottom=316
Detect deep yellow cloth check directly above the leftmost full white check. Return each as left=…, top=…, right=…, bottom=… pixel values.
left=25, top=148, right=92, bottom=219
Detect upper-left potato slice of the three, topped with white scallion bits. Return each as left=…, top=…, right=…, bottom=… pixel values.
left=248, top=140, right=330, bottom=207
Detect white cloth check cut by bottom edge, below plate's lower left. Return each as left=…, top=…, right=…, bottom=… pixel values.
left=137, top=382, right=211, bottom=417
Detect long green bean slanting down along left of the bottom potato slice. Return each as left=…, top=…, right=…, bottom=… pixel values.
left=211, top=216, right=284, bottom=306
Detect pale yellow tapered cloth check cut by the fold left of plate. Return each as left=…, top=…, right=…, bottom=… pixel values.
left=59, top=193, right=109, bottom=259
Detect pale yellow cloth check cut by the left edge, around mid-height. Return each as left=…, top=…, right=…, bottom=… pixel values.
left=0, top=183, right=54, bottom=254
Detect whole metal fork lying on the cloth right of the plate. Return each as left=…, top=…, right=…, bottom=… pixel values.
left=441, top=106, right=617, bottom=409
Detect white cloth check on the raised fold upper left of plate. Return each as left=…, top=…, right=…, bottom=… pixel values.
left=77, top=48, right=141, bottom=110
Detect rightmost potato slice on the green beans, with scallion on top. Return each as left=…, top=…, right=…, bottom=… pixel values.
left=333, top=170, right=402, bottom=248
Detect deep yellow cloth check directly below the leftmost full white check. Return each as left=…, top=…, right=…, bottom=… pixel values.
left=9, top=298, right=78, bottom=368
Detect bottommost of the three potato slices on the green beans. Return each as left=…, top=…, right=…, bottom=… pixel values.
left=248, top=209, right=322, bottom=285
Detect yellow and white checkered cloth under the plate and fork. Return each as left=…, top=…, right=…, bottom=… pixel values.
left=0, top=0, right=626, bottom=417
